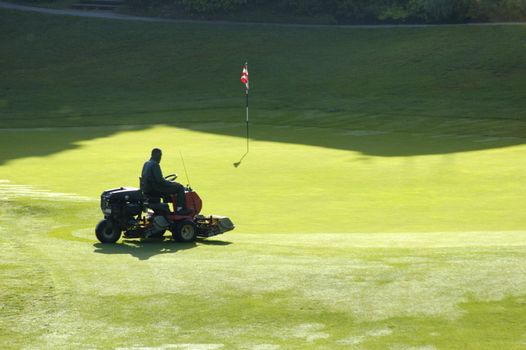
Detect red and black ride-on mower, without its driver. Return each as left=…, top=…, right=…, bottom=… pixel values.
left=95, top=175, right=235, bottom=243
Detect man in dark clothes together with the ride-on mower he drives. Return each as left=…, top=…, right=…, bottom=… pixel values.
left=95, top=148, right=234, bottom=243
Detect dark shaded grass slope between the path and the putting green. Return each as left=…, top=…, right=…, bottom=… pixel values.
left=0, top=10, right=526, bottom=135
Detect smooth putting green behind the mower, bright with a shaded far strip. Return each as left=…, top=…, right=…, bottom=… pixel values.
left=0, top=124, right=526, bottom=233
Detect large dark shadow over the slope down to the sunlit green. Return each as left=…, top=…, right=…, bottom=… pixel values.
left=0, top=8, right=526, bottom=167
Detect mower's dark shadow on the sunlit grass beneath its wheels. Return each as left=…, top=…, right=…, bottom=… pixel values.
left=93, top=237, right=232, bottom=260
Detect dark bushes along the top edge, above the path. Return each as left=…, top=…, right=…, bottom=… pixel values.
left=127, top=0, right=526, bottom=23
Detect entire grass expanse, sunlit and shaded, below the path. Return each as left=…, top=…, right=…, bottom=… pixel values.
left=0, top=6, right=526, bottom=350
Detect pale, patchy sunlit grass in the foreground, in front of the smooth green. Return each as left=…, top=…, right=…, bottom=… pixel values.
left=0, top=198, right=526, bottom=349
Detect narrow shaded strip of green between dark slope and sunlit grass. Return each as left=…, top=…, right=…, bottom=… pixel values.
left=0, top=115, right=526, bottom=167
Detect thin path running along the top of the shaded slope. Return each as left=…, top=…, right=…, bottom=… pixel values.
left=0, top=1, right=526, bottom=29
